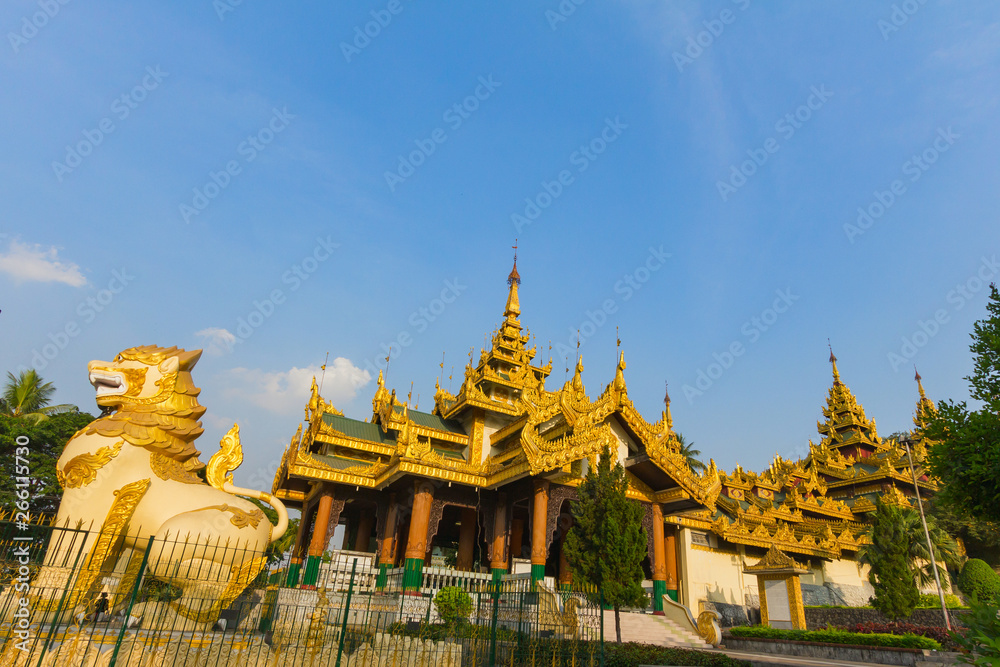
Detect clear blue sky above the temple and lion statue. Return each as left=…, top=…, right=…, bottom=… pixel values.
left=0, top=0, right=1000, bottom=486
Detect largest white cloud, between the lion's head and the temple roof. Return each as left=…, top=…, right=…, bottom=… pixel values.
left=223, top=357, right=371, bottom=414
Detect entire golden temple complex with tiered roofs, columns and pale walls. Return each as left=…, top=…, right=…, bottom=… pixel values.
left=272, top=256, right=936, bottom=611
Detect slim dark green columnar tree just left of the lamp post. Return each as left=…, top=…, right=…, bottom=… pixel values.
left=858, top=499, right=920, bottom=620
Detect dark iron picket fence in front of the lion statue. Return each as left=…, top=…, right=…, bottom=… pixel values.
left=0, top=521, right=604, bottom=667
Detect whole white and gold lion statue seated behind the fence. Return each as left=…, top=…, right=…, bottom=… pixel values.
left=12, top=346, right=288, bottom=627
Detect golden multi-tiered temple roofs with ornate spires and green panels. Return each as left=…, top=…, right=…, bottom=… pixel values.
left=273, top=257, right=936, bottom=558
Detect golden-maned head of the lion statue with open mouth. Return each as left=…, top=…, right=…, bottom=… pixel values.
left=86, top=345, right=205, bottom=470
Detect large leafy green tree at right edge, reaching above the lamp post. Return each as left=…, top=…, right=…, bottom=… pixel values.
left=925, top=284, right=1000, bottom=522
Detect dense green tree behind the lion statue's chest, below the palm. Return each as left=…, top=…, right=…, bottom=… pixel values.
left=0, top=411, right=94, bottom=515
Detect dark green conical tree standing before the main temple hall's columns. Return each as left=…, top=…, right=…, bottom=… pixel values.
left=564, top=448, right=646, bottom=641
